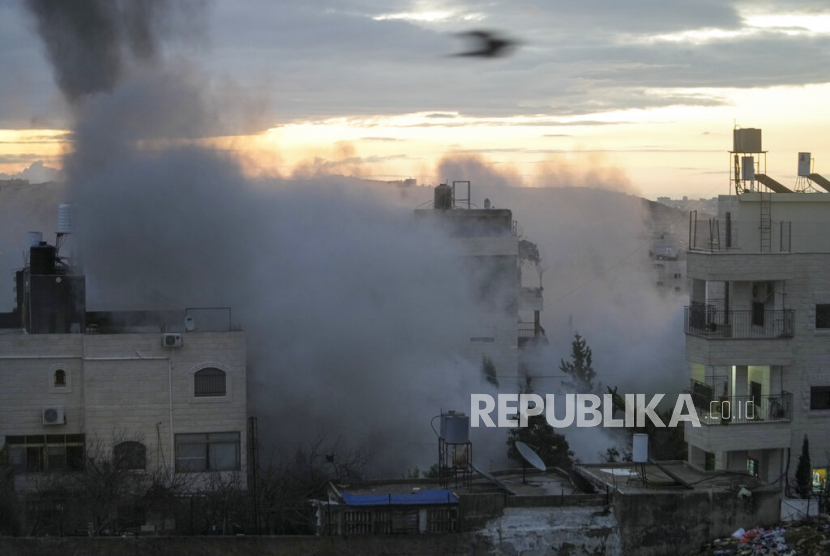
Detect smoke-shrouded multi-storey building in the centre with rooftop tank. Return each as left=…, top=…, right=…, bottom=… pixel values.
left=415, top=182, right=547, bottom=376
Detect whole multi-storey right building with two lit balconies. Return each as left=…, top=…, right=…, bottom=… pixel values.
left=685, top=189, right=830, bottom=485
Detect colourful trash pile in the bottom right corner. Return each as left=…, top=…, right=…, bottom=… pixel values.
left=692, top=515, right=830, bottom=556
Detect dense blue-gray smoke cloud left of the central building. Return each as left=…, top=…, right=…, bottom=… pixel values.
left=22, top=4, right=504, bottom=473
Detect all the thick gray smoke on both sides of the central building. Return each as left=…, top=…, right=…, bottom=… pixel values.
left=22, top=0, right=682, bottom=472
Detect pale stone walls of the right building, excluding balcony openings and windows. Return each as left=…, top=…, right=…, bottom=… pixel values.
left=686, top=200, right=830, bottom=474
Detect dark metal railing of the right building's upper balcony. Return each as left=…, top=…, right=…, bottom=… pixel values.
left=685, top=304, right=795, bottom=340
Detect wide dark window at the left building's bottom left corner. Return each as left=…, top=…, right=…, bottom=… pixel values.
left=6, top=434, right=84, bottom=474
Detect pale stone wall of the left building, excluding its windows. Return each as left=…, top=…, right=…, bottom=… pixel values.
left=0, top=332, right=247, bottom=484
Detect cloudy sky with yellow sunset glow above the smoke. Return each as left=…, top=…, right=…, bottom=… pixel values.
left=0, top=0, right=830, bottom=198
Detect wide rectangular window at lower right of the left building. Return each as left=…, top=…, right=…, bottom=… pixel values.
left=176, top=432, right=239, bottom=473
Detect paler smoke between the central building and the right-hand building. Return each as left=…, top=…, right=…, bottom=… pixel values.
left=437, top=157, right=688, bottom=461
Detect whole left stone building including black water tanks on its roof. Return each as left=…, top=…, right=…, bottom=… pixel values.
left=0, top=230, right=247, bottom=490
